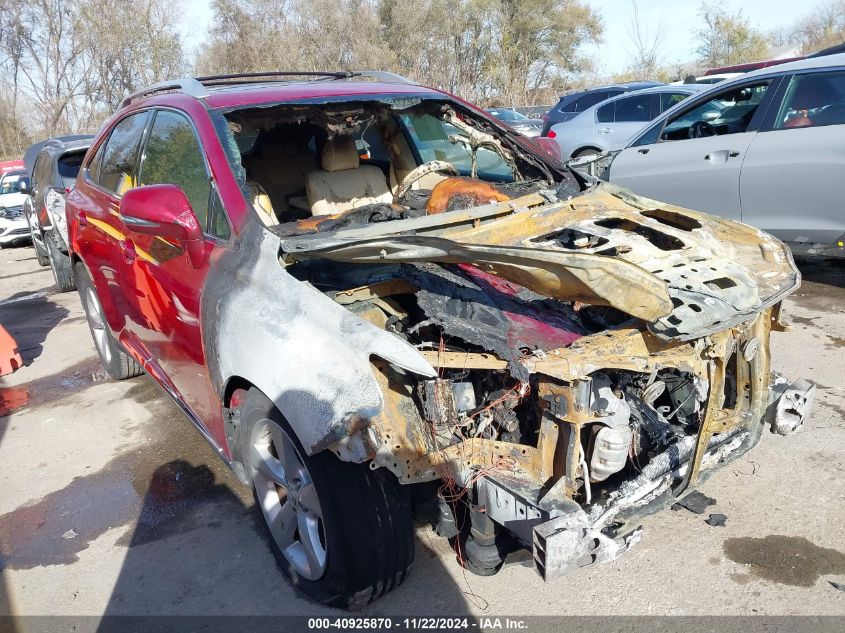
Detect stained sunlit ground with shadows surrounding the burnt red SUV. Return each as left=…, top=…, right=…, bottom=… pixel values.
left=0, top=246, right=845, bottom=616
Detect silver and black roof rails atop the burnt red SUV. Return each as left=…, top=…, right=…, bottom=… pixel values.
left=118, top=70, right=414, bottom=109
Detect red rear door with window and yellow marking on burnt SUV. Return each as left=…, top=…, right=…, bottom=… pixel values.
left=67, top=110, right=150, bottom=338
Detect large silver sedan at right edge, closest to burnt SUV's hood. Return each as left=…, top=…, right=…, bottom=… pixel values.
left=596, top=54, right=845, bottom=257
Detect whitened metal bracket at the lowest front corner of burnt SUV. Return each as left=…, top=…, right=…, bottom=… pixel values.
left=533, top=515, right=643, bottom=581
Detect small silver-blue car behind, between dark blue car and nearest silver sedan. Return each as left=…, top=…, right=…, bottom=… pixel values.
left=549, top=84, right=706, bottom=160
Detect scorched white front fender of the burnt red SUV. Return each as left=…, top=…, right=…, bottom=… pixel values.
left=202, top=223, right=436, bottom=455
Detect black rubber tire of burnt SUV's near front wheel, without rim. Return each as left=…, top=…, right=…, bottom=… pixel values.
left=240, top=388, right=414, bottom=609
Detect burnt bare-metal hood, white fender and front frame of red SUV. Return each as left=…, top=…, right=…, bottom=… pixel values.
left=193, top=91, right=812, bottom=577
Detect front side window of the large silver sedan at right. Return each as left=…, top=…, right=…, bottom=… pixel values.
left=660, top=79, right=771, bottom=141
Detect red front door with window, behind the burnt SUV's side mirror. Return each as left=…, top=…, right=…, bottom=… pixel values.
left=121, top=109, right=228, bottom=447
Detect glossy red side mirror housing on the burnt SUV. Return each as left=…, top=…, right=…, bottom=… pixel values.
left=120, top=185, right=205, bottom=268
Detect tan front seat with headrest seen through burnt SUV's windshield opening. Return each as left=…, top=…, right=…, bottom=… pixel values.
left=305, top=136, right=393, bottom=215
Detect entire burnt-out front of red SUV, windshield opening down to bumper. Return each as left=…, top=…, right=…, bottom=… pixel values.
left=203, top=95, right=814, bottom=579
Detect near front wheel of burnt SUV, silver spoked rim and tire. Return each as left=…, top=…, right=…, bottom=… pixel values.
left=240, top=388, right=414, bottom=609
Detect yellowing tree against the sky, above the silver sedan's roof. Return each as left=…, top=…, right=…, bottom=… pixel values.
left=693, top=0, right=769, bottom=67
